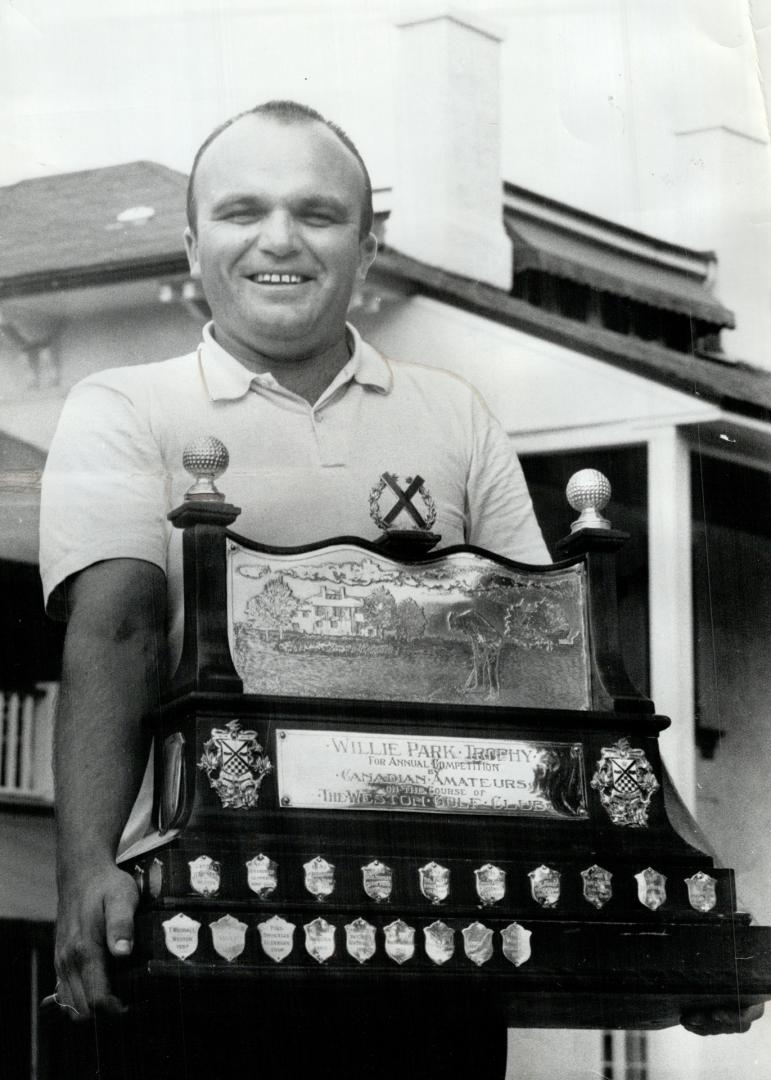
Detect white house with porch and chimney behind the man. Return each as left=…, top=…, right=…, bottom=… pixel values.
left=0, top=8, right=771, bottom=1080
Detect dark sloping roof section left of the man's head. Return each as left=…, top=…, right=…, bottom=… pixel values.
left=0, top=161, right=187, bottom=297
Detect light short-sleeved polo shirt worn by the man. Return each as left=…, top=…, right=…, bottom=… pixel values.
left=40, top=324, right=551, bottom=855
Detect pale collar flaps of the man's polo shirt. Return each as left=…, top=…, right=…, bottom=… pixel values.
left=199, top=322, right=393, bottom=402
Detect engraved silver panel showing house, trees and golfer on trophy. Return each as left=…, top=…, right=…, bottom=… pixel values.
left=226, top=548, right=591, bottom=708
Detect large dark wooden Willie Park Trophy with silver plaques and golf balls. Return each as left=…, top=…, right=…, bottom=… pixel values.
left=113, top=438, right=771, bottom=1028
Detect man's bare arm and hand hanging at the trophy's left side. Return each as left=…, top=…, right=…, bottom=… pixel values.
left=54, top=559, right=165, bottom=1017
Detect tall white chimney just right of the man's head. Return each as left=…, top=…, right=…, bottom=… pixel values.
left=386, top=12, right=512, bottom=291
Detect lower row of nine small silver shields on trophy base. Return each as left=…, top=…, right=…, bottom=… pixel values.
left=163, top=913, right=532, bottom=968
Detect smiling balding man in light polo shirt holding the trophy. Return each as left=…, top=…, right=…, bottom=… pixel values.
left=41, top=102, right=549, bottom=1080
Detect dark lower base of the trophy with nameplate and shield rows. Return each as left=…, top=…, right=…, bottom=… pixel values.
left=117, top=694, right=771, bottom=1028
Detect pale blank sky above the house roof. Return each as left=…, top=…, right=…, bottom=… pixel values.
left=0, top=0, right=771, bottom=364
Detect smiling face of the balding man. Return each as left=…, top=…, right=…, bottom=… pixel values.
left=186, top=116, right=377, bottom=361
